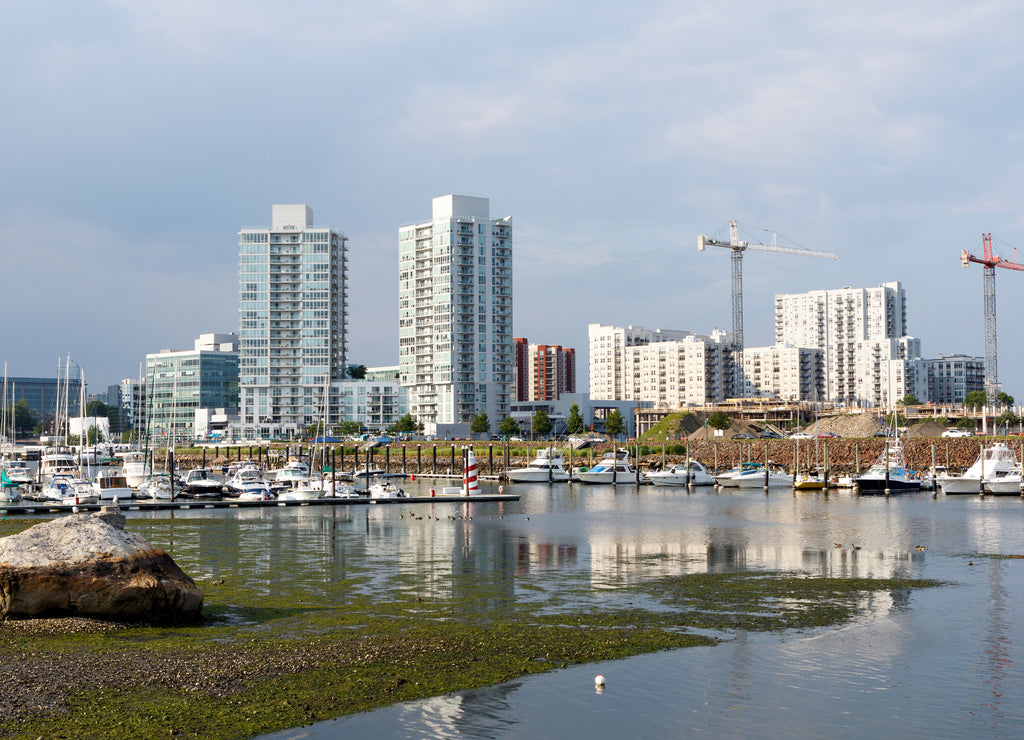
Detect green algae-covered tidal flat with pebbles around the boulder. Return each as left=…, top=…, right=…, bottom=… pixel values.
left=0, top=512, right=940, bottom=738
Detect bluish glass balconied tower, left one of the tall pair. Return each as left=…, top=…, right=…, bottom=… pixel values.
left=239, top=205, right=347, bottom=437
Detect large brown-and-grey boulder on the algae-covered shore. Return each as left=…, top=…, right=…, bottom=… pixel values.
left=0, top=511, right=203, bottom=622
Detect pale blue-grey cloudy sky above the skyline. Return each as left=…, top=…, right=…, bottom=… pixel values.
left=0, top=0, right=1024, bottom=399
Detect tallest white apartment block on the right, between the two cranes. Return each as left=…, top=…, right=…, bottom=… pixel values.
left=775, top=282, right=921, bottom=405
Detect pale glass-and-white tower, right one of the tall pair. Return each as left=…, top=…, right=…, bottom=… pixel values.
left=398, top=195, right=513, bottom=434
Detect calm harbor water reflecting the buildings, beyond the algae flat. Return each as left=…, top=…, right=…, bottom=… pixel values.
left=129, top=481, right=1024, bottom=738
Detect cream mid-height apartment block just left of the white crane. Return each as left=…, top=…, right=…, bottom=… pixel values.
left=588, top=323, right=733, bottom=408
